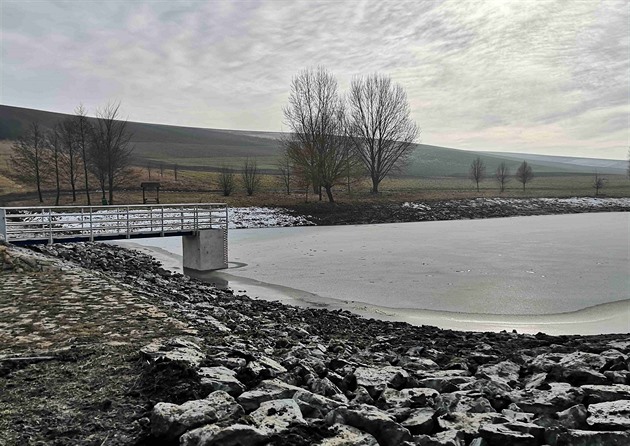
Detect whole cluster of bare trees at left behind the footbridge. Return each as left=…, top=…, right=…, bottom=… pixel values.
left=9, top=103, right=134, bottom=206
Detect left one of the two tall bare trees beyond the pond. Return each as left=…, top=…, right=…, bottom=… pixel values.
left=281, top=67, right=350, bottom=203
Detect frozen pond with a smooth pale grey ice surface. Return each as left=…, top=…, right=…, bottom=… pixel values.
left=119, top=213, right=630, bottom=333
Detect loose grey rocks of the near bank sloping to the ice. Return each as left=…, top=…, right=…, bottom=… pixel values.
left=28, top=244, right=630, bottom=446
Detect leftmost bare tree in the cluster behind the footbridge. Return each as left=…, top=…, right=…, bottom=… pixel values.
left=10, top=122, right=46, bottom=203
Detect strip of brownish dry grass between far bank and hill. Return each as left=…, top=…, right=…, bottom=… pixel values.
left=0, top=142, right=630, bottom=206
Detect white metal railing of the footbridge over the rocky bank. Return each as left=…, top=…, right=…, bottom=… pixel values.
left=0, top=203, right=228, bottom=243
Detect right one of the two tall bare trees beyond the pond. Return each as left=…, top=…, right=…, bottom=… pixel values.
left=348, top=74, right=419, bottom=194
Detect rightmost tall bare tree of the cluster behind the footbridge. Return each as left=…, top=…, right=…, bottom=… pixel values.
left=91, top=103, right=133, bottom=204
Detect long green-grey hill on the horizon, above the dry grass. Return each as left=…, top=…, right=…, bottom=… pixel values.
left=0, top=105, right=627, bottom=177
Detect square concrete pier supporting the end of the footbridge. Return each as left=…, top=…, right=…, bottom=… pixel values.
left=182, top=228, right=227, bottom=271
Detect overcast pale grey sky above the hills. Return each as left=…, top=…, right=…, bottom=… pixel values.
left=0, top=0, right=630, bottom=159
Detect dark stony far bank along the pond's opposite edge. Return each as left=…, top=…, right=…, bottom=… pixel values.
left=289, top=198, right=630, bottom=225
